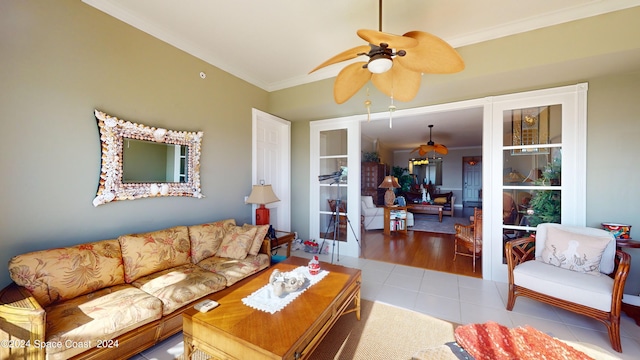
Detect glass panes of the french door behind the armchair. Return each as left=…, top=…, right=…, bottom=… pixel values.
left=502, top=105, right=562, bottom=262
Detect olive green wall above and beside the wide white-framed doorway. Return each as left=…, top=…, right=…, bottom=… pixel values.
left=269, top=7, right=640, bottom=293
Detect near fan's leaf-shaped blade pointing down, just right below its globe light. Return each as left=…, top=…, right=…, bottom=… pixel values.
left=371, top=59, right=421, bottom=102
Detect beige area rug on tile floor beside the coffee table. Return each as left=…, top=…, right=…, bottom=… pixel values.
left=309, top=300, right=456, bottom=360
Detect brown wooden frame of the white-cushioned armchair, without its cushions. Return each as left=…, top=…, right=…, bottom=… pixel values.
left=505, top=237, right=631, bottom=352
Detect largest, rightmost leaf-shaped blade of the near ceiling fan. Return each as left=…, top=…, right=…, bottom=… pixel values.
left=393, top=31, right=464, bottom=74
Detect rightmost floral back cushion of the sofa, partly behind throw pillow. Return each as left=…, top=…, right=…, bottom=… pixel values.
left=189, top=219, right=236, bottom=264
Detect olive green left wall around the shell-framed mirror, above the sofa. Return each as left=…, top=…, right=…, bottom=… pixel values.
left=0, top=0, right=268, bottom=286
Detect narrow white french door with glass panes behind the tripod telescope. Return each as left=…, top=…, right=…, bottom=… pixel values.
left=309, top=119, right=361, bottom=260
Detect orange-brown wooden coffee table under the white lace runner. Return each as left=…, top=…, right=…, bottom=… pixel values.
left=183, top=256, right=362, bottom=359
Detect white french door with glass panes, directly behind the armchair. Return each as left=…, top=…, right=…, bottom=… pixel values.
left=483, top=84, right=587, bottom=280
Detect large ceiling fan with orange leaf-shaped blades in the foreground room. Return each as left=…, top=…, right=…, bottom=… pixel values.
left=309, top=0, right=464, bottom=104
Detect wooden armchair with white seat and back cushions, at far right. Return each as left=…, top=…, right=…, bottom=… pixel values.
left=505, top=224, right=631, bottom=352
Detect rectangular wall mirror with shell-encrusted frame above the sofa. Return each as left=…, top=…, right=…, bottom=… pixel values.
left=93, top=110, right=204, bottom=206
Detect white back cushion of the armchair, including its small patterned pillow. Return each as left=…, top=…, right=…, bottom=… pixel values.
left=536, top=224, right=615, bottom=275
